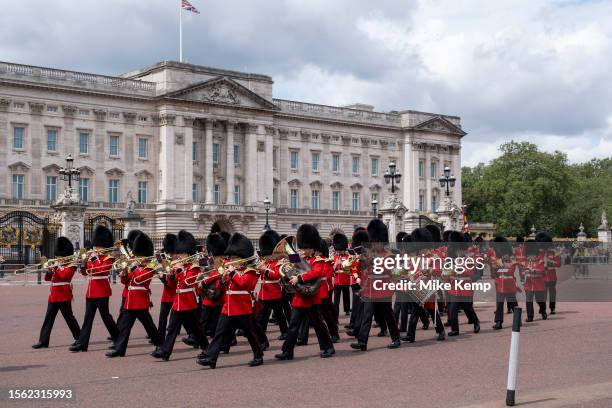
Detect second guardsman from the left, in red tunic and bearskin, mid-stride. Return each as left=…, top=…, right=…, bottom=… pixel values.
left=69, top=225, right=119, bottom=352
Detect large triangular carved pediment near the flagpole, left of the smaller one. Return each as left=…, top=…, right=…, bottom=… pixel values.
left=163, top=77, right=278, bottom=110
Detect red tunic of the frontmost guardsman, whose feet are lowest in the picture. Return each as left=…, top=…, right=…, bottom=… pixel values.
left=219, top=267, right=259, bottom=316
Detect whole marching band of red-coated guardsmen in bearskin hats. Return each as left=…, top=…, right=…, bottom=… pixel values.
left=32, top=218, right=561, bottom=369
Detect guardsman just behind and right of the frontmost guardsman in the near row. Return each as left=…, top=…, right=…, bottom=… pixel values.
left=256, top=230, right=287, bottom=344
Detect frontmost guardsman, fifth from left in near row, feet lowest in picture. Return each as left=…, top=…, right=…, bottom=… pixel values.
left=196, top=233, right=263, bottom=368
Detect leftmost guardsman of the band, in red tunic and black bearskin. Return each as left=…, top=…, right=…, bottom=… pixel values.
left=32, top=237, right=81, bottom=349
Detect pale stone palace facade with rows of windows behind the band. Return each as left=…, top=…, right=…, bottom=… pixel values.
left=0, top=61, right=465, bottom=238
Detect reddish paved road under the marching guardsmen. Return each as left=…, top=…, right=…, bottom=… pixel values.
left=0, top=285, right=612, bottom=407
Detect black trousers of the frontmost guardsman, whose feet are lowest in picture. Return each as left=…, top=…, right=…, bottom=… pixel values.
left=205, top=314, right=263, bottom=361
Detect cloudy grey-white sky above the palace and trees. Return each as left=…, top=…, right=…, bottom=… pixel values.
left=0, top=0, right=612, bottom=165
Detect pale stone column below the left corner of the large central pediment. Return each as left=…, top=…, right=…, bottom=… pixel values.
left=158, top=113, right=177, bottom=209
